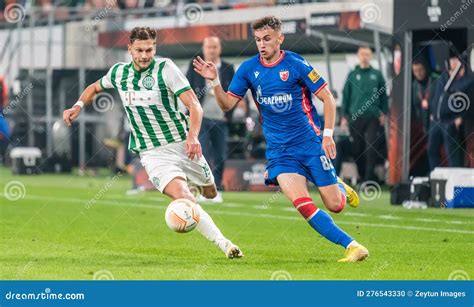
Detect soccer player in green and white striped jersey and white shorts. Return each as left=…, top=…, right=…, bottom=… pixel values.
left=63, top=27, right=243, bottom=258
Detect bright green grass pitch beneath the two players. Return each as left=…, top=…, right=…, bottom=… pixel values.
left=0, top=169, right=474, bottom=280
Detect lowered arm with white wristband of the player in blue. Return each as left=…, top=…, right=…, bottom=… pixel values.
left=316, top=86, right=336, bottom=159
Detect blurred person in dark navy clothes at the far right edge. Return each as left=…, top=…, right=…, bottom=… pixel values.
left=428, top=55, right=474, bottom=170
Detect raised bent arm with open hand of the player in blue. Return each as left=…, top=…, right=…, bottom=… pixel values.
left=193, top=56, right=242, bottom=112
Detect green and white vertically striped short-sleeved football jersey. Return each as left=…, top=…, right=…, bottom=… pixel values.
left=100, top=58, right=191, bottom=152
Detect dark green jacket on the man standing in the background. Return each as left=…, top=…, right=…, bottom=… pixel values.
left=342, top=65, right=388, bottom=121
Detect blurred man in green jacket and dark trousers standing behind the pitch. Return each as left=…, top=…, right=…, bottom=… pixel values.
left=341, top=46, right=388, bottom=181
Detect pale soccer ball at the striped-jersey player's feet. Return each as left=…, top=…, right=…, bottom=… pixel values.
left=165, top=198, right=200, bottom=232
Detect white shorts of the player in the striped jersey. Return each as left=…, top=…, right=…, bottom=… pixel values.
left=140, top=141, right=214, bottom=193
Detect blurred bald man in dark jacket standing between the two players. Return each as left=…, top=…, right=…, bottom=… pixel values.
left=186, top=36, right=234, bottom=202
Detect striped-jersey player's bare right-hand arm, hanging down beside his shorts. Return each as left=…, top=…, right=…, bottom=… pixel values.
left=178, top=89, right=202, bottom=160
